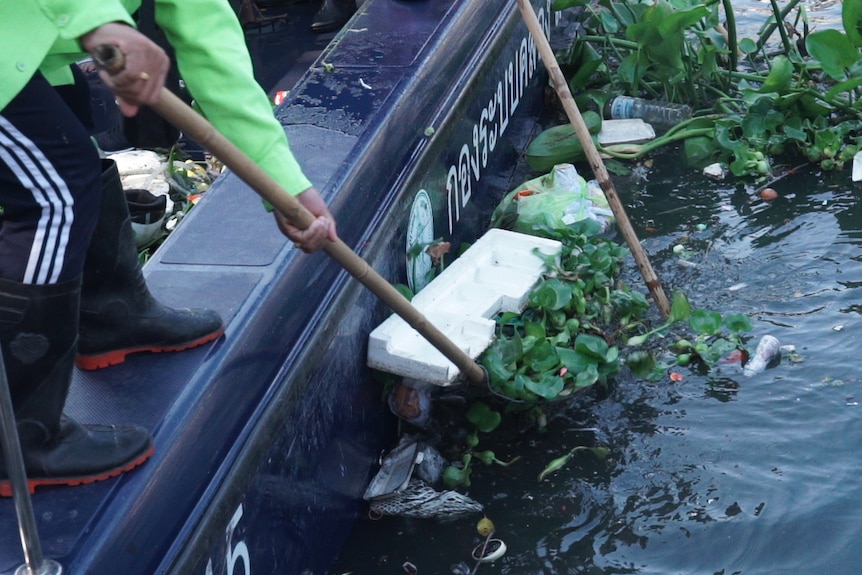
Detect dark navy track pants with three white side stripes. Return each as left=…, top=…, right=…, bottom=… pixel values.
left=0, top=74, right=101, bottom=284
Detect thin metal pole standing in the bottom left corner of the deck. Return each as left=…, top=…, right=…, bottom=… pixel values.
left=0, top=350, right=63, bottom=575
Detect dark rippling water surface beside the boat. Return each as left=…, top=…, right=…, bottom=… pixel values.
left=331, top=3, right=862, bottom=575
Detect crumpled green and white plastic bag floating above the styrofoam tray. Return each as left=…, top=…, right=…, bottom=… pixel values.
left=491, top=164, right=613, bottom=234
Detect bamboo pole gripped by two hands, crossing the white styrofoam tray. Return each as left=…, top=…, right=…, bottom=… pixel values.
left=93, top=45, right=487, bottom=384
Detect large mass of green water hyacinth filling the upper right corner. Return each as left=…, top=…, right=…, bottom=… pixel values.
left=540, top=0, right=862, bottom=180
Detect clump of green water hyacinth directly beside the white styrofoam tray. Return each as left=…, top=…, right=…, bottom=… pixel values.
left=479, top=220, right=649, bottom=402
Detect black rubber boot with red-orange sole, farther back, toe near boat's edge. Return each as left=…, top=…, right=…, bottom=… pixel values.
left=77, top=160, right=224, bottom=369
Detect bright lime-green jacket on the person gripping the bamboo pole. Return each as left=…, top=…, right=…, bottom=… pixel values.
left=0, top=0, right=311, bottom=195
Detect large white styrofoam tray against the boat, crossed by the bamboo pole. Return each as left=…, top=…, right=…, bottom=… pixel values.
left=368, top=228, right=561, bottom=386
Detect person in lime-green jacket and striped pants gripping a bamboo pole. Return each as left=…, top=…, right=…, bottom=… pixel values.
left=0, top=0, right=337, bottom=496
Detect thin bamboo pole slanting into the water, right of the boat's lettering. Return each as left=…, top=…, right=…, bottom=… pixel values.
left=517, top=0, right=670, bottom=319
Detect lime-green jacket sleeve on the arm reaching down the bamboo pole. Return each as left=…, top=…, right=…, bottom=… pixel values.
left=156, top=0, right=318, bottom=195
